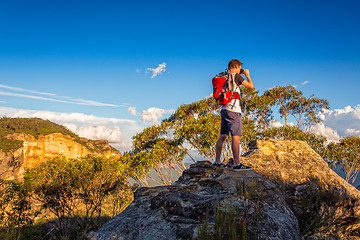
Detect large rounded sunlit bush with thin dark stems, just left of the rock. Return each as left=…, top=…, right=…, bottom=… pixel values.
left=20, top=156, right=132, bottom=239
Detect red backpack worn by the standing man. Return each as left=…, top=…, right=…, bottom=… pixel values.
left=212, top=72, right=240, bottom=105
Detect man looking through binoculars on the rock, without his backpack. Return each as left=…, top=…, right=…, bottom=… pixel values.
left=214, top=59, right=254, bottom=170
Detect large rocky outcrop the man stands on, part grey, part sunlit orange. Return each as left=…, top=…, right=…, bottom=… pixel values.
left=88, top=140, right=360, bottom=240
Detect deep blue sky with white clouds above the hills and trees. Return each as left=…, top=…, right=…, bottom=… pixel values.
left=0, top=0, right=360, bottom=150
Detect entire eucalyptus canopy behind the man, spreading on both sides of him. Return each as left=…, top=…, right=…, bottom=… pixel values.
left=122, top=85, right=359, bottom=185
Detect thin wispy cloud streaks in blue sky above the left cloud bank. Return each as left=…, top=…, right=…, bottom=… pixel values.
left=0, top=85, right=128, bottom=107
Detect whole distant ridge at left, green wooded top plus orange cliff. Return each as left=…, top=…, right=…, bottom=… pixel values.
left=0, top=117, right=121, bottom=179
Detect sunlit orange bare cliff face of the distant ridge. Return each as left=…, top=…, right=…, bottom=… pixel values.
left=0, top=133, right=121, bottom=179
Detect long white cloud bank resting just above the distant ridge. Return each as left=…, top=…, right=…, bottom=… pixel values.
left=0, top=107, right=143, bottom=151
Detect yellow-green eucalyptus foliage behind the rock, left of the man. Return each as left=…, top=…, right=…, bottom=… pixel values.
left=126, top=98, right=219, bottom=186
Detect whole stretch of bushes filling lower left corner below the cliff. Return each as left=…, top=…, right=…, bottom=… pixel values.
left=0, top=156, right=133, bottom=239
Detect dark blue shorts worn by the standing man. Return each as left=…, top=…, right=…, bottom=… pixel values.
left=220, top=109, right=242, bottom=136
